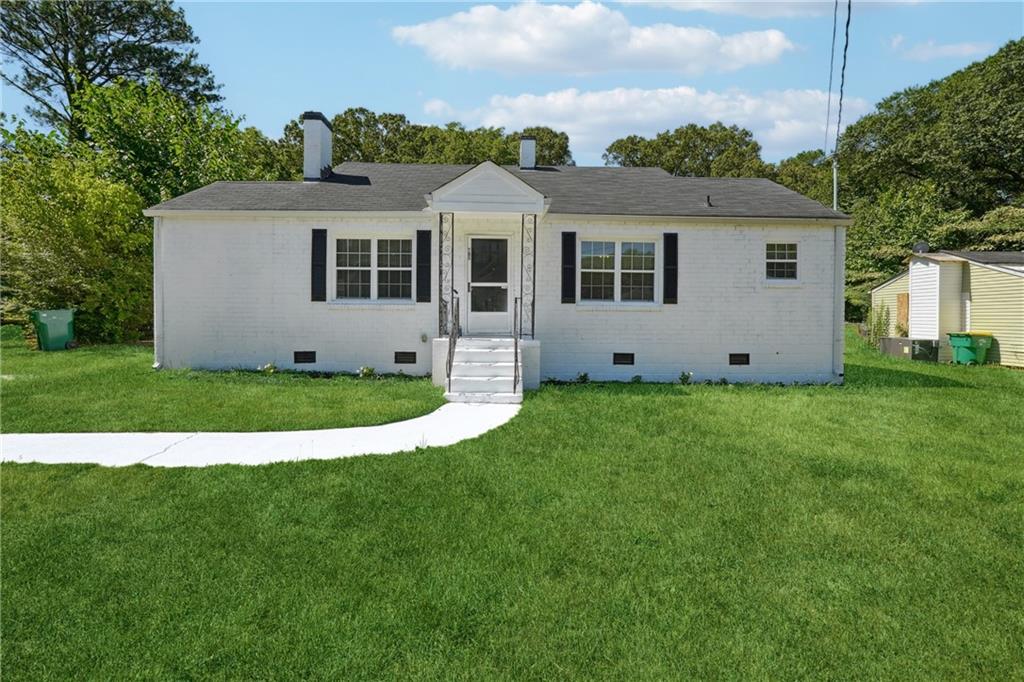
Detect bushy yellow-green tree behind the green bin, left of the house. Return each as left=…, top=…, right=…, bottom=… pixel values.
left=0, top=120, right=153, bottom=341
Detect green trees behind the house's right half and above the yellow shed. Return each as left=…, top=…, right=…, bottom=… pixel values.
left=604, top=40, right=1024, bottom=319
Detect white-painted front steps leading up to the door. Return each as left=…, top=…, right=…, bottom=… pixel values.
left=444, top=337, right=522, bottom=403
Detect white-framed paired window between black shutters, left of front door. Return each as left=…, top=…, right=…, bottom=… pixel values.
left=336, top=239, right=413, bottom=300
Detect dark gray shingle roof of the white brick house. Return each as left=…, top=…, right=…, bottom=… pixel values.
left=153, top=162, right=847, bottom=219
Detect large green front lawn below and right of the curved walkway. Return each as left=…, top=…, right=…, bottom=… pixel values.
left=0, top=327, right=1024, bottom=680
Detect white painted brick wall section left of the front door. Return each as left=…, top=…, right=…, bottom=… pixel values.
left=156, top=216, right=437, bottom=375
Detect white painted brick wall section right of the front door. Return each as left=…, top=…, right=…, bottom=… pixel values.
left=538, top=219, right=834, bottom=382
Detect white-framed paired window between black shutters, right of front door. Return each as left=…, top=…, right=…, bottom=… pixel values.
left=580, top=242, right=655, bottom=302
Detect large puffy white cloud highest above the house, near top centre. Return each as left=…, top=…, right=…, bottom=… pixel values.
left=392, top=1, right=794, bottom=74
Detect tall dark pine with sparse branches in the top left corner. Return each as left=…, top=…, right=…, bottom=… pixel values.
left=0, top=0, right=220, bottom=139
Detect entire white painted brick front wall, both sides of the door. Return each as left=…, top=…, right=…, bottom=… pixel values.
left=156, top=214, right=842, bottom=382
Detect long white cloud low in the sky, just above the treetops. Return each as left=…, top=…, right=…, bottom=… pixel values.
left=440, top=86, right=869, bottom=164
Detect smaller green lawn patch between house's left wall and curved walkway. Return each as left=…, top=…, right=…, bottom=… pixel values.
left=0, top=327, right=444, bottom=433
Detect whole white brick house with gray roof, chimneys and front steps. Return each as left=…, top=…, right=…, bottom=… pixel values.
left=146, top=112, right=850, bottom=401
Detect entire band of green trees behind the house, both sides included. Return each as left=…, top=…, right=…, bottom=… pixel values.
left=0, top=0, right=1024, bottom=340
